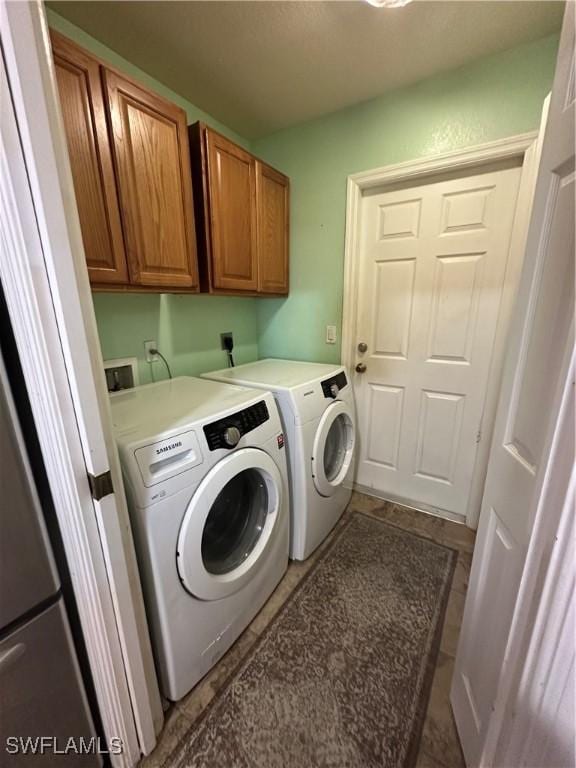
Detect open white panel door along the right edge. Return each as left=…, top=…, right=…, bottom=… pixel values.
left=451, top=3, right=575, bottom=766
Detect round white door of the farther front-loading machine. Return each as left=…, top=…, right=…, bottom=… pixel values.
left=312, top=400, right=356, bottom=496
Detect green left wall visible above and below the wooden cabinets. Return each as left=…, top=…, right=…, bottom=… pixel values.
left=47, top=9, right=258, bottom=384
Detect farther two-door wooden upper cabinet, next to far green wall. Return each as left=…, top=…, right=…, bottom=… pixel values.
left=189, top=123, right=290, bottom=296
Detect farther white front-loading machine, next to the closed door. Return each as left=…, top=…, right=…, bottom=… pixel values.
left=202, top=360, right=356, bottom=560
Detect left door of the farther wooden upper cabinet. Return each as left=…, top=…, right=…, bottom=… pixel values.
left=206, top=129, right=258, bottom=293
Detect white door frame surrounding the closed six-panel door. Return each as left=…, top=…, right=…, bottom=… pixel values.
left=341, top=130, right=547, bottom=528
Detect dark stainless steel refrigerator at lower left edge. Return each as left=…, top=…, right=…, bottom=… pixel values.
left=0, top=354, right=102, bottom=768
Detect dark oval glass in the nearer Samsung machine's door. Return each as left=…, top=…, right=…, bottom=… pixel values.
left=202, top=469, right=269, bottom=575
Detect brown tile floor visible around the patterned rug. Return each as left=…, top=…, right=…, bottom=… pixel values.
left=140, top=492, right=474, bottom=768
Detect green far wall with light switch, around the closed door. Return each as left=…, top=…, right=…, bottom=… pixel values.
left=252, top=36, right=558, bottom=362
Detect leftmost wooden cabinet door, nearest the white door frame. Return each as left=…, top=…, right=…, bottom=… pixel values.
left=52, top=32, right=128, bottom=283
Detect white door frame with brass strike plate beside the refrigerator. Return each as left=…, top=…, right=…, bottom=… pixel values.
left=0, top=1, right=163, bottom=768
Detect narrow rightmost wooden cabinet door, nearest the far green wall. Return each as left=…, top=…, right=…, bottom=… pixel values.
left=257, top=162, right=290, bottom=294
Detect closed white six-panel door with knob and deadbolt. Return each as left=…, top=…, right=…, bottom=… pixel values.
left=355, top=161, right=520, bottom=516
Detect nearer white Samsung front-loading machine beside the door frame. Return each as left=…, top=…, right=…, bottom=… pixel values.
left=110, top=377, right=290, bottom=701
